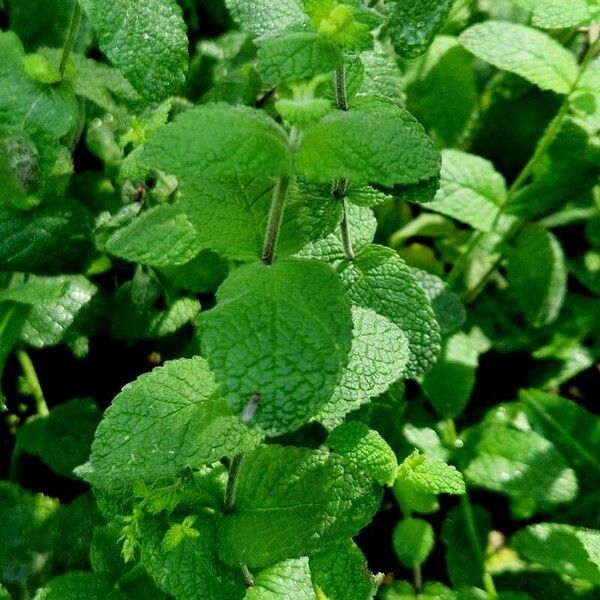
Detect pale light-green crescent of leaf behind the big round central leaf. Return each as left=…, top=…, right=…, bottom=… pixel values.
left=315, top=306, right=409, bottom=428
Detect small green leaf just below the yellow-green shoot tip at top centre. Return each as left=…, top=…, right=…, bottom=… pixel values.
left=256, top=32, right=344, bottom=84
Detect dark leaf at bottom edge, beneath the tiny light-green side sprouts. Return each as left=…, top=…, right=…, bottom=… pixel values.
left=140, top=514, right=245, bottom=600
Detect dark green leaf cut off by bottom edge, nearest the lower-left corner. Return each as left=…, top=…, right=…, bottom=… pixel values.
left=34, top=571, right=120, bottom=600
